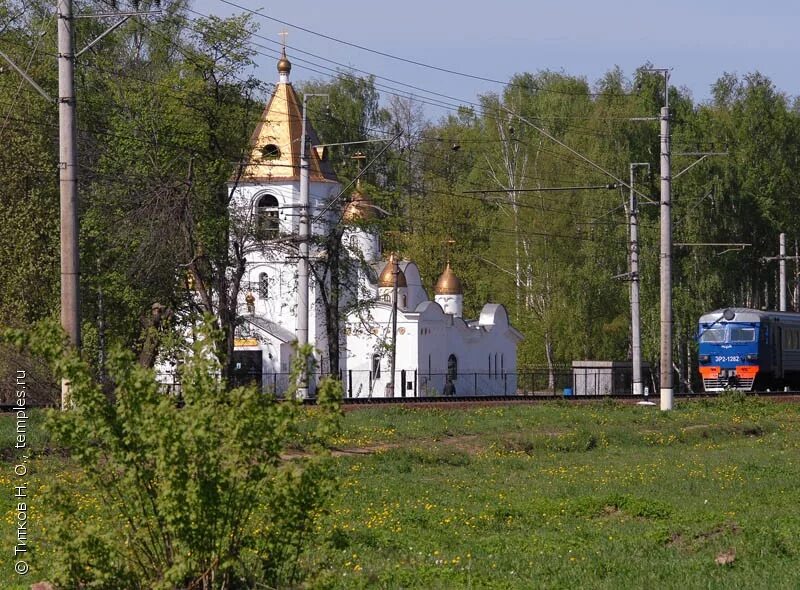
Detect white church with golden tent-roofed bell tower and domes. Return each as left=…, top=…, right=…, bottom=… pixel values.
left=229, top=52, right=522, bottom=398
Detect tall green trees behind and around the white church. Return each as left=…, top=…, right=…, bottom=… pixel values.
left=0, top=0, right=800, bottom=402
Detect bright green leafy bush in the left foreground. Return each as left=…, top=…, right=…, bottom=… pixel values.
left=6, top=325, right=341, bottom=590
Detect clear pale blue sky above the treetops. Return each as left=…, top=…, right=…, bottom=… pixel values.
left=193, top=0, right=800, bottom=119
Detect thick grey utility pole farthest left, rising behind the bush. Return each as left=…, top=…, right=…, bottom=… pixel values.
left=56, top=0, right=81, bottom=410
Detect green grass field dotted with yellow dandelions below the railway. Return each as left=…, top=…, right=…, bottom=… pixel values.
left=0, top=397, right=800, bottom=589
